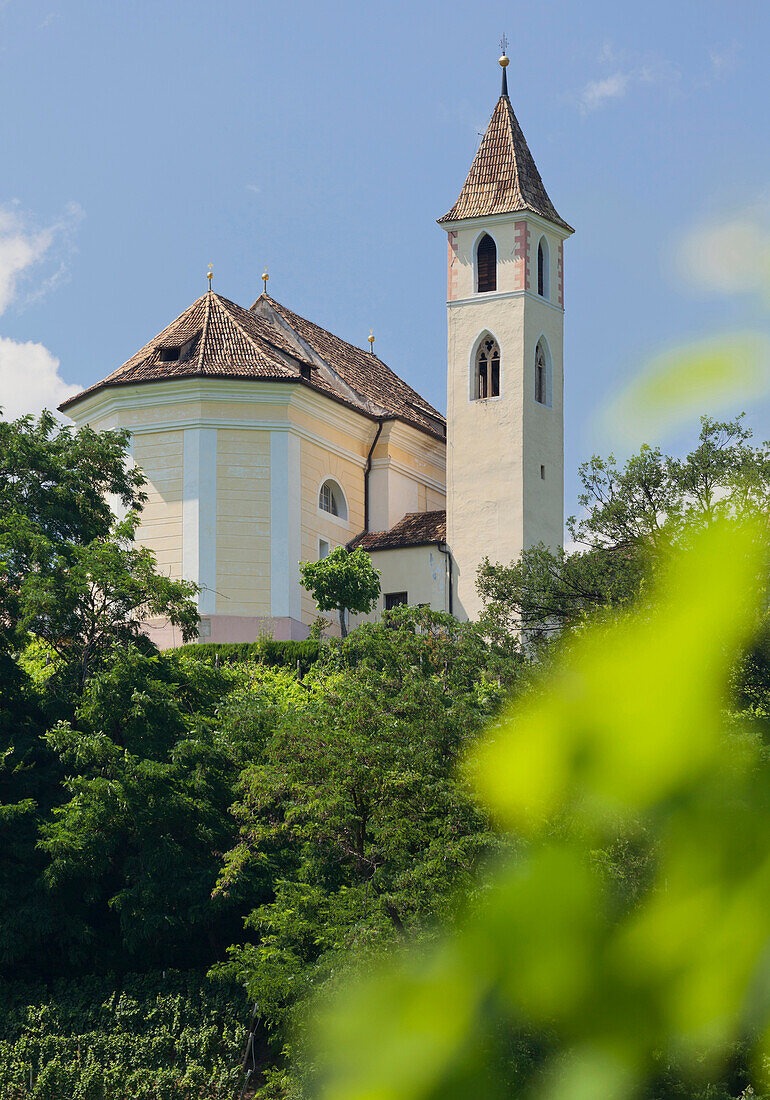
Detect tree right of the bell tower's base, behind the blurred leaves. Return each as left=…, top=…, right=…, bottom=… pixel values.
left=479, top=415, right=770, bottom=640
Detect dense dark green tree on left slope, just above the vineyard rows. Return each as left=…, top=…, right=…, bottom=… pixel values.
left=40, top=647, right=253, bottom=967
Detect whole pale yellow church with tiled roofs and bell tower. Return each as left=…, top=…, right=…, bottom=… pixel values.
left=61, top=54, right=573, bottom=646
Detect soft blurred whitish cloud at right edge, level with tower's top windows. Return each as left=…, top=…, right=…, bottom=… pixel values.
left=675, top=204, right=770, bottom=295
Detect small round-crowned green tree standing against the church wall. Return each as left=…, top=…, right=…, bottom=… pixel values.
left=299, top=547, right=380, bottom=638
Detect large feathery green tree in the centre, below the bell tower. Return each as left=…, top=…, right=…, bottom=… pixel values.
left=213, top=608, right=520, bottom=1082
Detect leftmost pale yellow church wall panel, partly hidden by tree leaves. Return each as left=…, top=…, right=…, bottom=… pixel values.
left=132, top=431, right=184, bottom=576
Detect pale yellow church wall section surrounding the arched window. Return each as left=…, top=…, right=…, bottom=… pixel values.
left=297, top=439, right=364, bottom=633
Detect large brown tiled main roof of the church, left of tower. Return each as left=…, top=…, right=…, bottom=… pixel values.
left=59, top=290, right=446, bottom=439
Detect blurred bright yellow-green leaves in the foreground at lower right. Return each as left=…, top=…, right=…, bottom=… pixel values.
left=305, top=524, right=770, bottom=1100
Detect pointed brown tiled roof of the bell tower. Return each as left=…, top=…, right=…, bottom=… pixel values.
left=439, top=95, right=572, bottom=232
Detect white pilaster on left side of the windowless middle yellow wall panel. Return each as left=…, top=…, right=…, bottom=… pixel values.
left=182, top=428, right=217, bottom=615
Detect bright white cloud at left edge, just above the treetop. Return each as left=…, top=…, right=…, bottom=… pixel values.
left=0, top=337, right=81, bottom=420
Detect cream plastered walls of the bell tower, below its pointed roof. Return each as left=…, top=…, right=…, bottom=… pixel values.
left=446, top=213, right=567, bottom=619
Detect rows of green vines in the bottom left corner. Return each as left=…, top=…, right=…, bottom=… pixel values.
left=0, top=971, right=249, bottom=1100
